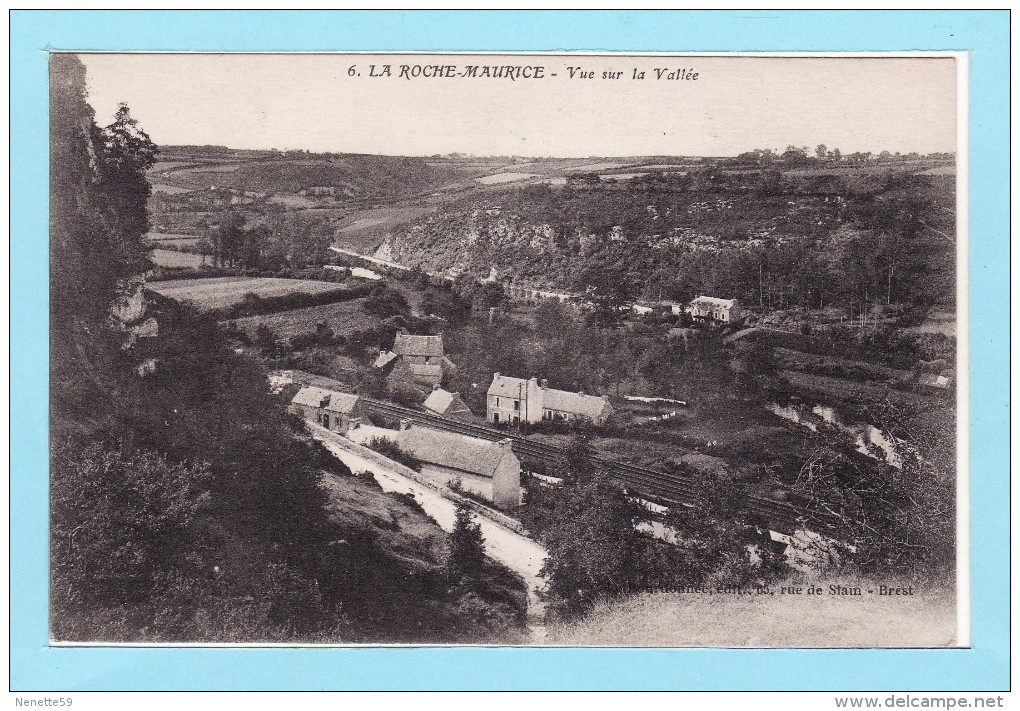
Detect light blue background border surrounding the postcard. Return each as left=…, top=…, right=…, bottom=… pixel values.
left=10, top=10, right=1010, bottom=691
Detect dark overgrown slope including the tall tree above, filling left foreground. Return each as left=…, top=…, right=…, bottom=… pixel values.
left=50, top=54, right=523, bottom=643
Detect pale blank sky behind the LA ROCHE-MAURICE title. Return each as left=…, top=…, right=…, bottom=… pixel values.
left=81, top=53, right=957, bottom=157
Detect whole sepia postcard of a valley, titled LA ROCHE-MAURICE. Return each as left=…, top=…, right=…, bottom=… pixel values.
left=49, top=51, right=969, bottom=648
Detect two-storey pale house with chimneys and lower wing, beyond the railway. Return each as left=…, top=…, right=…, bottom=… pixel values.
left=486, top=372, right=613, bottom=424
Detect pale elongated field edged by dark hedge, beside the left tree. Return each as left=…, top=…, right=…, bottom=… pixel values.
left=149, top=276, right=338, bottom=311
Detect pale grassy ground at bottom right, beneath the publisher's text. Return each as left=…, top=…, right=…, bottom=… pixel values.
left=547, top=580, right=956, bottom=648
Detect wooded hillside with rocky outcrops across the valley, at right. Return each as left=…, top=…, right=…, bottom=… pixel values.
left=392, top=166, right=956, bottom=313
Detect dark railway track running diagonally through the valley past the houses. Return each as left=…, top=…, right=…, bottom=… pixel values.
left=363, top=398, right=826, bottom=532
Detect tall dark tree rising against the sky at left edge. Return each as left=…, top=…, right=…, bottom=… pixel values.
left=50, top=53, right=156, bottom=338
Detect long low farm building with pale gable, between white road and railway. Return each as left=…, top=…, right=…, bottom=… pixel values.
left=399, top=420, right=520, bottom=508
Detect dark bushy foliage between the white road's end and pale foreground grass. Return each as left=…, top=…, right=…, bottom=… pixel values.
left=522, top=432, right=786, bottom=617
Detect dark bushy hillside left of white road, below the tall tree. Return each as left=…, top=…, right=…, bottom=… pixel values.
left=54, top=289, right=525, bottom=644
